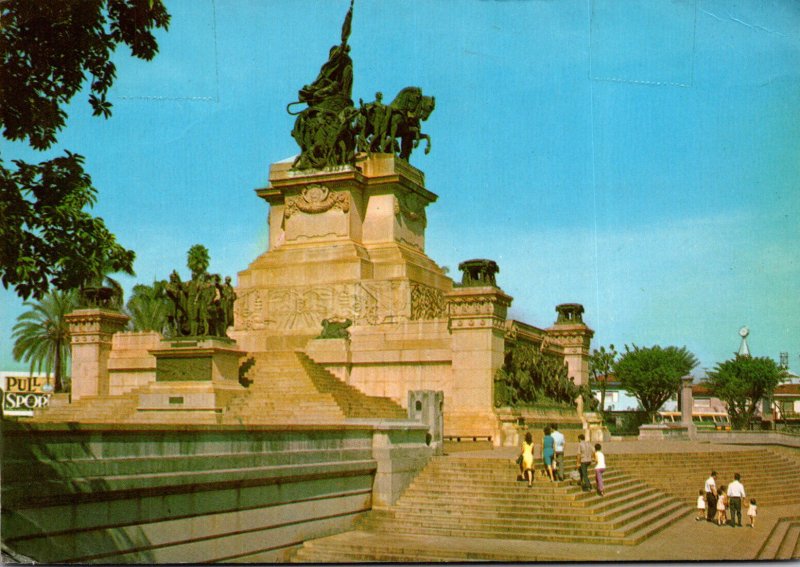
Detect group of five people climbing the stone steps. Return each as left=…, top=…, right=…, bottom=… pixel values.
left=517, top=423, right=606, bottom=496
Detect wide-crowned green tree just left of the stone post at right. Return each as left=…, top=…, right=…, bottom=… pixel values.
left=614, top=345, right=697, bottom=420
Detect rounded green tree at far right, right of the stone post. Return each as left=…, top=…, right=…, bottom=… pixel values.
left=705, top=354, right=784, bottom=429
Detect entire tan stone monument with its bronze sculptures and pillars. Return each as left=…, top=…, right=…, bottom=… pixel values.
left=59, top=2, right=593, bottom=444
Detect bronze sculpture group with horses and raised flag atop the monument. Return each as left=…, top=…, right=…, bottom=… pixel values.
left=287, top=0, right=436, bottom=169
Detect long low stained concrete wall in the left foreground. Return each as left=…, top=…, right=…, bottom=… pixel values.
left=2, top=422, right=431, bottom=563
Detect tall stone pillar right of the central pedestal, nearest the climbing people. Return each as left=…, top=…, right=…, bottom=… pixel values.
left=445, top=286, right=513, bottom=444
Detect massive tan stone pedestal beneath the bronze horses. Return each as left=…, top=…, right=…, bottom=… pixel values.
left=231, top=154, right=452, bottom=351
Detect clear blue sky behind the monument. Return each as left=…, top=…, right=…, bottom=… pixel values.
left=0, top=0, right=800, bottom=378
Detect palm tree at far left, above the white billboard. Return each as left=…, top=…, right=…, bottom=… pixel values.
left=11, top=291, right=77, bottom=392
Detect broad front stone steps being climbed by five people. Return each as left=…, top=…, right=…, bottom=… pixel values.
left=295, top=457, right=692, bottom=562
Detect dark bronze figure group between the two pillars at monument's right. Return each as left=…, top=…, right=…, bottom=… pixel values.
left=495, top=342, right=589, bottom=407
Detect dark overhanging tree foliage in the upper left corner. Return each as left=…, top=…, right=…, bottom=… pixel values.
left=0, top=0, right=169, bottom=299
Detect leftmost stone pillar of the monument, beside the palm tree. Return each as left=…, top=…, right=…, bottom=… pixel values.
left=65, top=307, right=130, bottom=401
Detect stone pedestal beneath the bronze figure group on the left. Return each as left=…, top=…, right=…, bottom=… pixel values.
left=137, top=338, right=245, bottom=415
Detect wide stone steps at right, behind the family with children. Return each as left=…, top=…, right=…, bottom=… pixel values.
left=614, top=448, right=800, bottom=512
